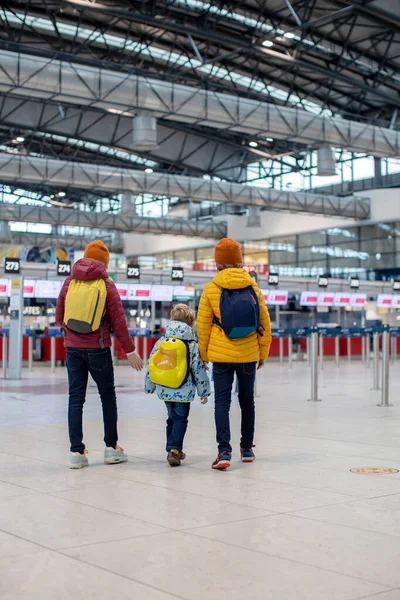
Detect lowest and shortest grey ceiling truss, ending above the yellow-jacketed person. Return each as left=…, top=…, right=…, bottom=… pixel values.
left=0, top=204, right=226, bottom=239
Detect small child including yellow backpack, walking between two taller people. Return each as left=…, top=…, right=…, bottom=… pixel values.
left=145, top=304, right=211, bottom=466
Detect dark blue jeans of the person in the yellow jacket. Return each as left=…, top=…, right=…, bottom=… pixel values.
left=213, top=362, right=257, bottom=454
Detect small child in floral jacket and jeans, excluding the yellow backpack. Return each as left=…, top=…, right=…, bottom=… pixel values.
left=145, top=304, right=211, bottom=466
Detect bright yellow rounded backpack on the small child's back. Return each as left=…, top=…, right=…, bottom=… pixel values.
left=148, top=338, right=190, bottom=390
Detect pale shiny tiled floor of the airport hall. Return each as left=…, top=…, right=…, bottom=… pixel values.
left=0, top=361, right=400, bottom=600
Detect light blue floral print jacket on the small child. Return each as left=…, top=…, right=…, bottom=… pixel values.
left=144, top=321, right=211, bottom=402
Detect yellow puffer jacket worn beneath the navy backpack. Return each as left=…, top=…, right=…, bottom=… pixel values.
left=197, top=269, right=271, bottom=363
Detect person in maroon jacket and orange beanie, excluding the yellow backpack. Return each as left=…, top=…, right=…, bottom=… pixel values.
left=56, top=240, right=143, bottom=469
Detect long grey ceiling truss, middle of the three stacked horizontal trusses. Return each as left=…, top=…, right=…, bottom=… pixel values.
left=0, top=153, right=370, bottom=219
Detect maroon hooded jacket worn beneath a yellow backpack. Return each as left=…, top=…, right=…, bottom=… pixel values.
left=56, top=258, right=135, bottom=354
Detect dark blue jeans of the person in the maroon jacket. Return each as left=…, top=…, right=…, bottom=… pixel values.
left=67, top=348, right=118, bottom=454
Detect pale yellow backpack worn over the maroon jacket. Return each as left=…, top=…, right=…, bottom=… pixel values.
left=64, top=279, right=107, bottom=333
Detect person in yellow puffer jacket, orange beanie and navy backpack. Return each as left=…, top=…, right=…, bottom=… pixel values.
left=197, top=238, right=271, bottom=469
